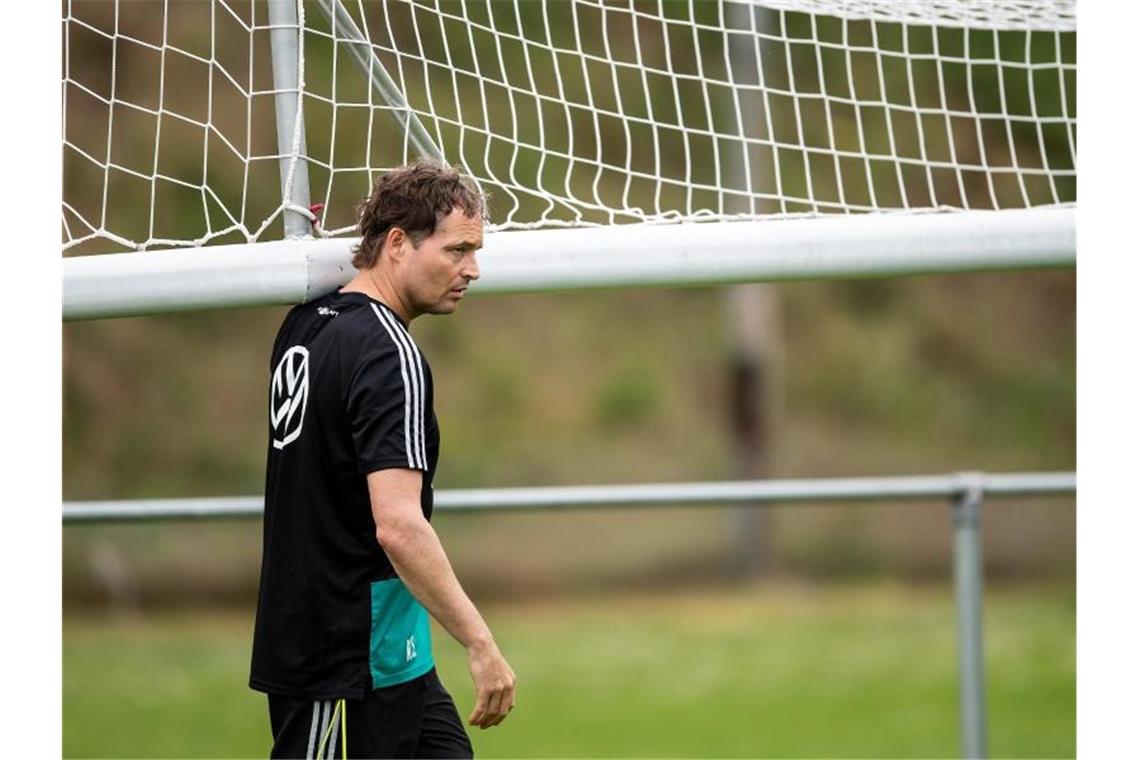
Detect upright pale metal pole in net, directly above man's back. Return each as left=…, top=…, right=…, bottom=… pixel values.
left=269, top=0, right=312, bottom=238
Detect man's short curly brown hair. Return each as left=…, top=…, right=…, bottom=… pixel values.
left=352, top=161, right=487, bottom=269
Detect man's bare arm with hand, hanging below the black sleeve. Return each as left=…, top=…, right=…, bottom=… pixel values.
left=368, top=469, right=515, bottom=728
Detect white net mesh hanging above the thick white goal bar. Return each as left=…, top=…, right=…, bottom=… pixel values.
left=63, top=0, right=1076, bottom=253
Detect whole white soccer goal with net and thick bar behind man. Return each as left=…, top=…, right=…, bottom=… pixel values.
left=63, top=0, right=1076, bottom=319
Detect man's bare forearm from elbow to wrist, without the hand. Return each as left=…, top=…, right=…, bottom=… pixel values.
left=377, top=518, right=492, bottom=648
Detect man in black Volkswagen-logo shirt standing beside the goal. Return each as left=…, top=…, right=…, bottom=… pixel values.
left=250, top=157, right=515, bottom=758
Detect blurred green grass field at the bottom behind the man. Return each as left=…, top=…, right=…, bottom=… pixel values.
left=63, top=583, right=1076, bottom=758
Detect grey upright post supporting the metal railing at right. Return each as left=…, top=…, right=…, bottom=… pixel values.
left=953, top=477, right=986, bottom=759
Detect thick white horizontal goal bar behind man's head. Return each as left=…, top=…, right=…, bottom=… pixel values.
left=63, top=207, right=1076, bottom=320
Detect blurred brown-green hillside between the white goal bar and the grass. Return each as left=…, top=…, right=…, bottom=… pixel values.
left=64, top=267, right=1075, bottom=603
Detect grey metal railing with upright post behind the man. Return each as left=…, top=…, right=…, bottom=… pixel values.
left=63, top=472, right=1076, bottom=758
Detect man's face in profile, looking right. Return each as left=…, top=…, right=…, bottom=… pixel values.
left=402, top=207, right=483, bottom=314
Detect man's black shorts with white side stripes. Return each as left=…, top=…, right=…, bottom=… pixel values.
left=269, top=668, right=474, bottom=758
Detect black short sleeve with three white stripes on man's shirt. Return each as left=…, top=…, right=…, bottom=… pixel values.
left=347, top=336, right=428, bottom=474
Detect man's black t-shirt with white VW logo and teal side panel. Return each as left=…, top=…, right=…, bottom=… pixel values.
left=250, top=292, right=439, bottom=700
